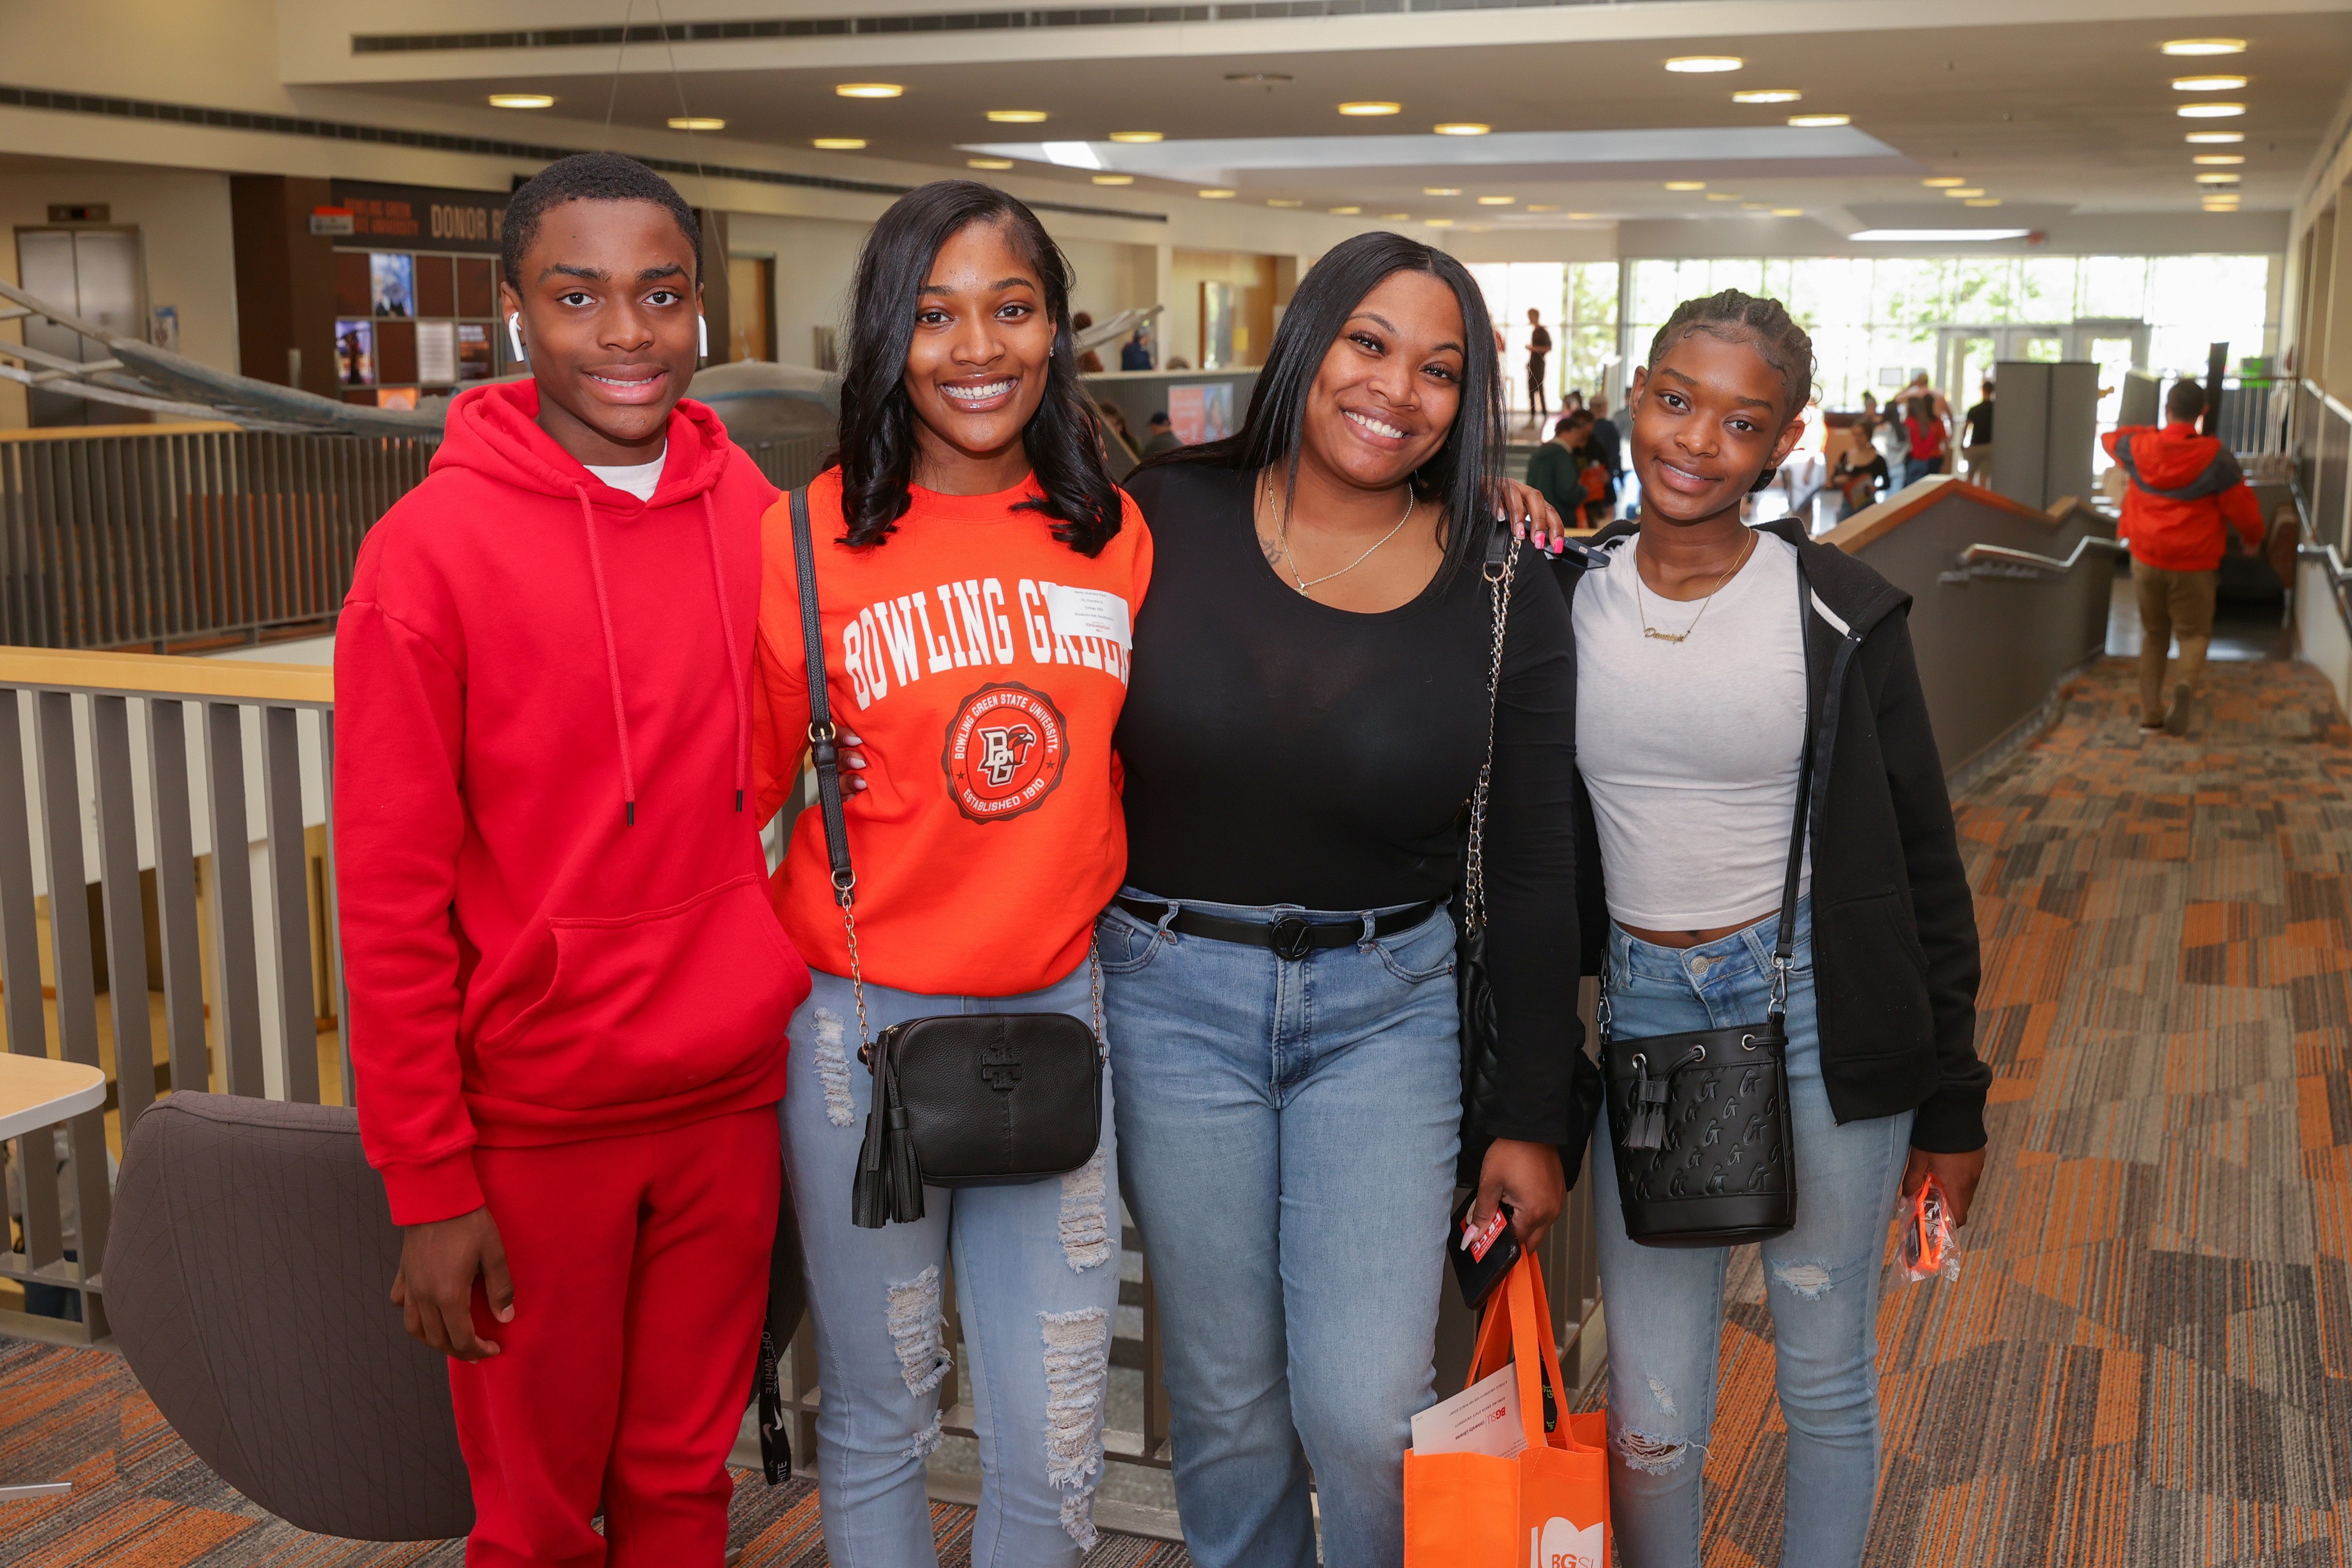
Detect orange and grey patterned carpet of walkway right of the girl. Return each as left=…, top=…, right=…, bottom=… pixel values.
left=1708, top=658, right=2352, bottom=1568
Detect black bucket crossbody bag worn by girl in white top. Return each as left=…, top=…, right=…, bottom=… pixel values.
left=1599, top=559, right=1814, bottom=1246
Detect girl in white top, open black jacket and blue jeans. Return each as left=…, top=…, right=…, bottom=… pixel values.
left=1555, top=289, right=1992, bottom=1568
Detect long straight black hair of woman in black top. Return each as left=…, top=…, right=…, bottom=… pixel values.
left=1150, top=230, right=1503, bottom=588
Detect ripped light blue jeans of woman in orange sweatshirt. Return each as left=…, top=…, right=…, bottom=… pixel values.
left=781, top=964, right=1120, bottom=1568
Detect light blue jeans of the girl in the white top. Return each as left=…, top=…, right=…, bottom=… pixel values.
left=1593, top=900, right=1912, bottom=1568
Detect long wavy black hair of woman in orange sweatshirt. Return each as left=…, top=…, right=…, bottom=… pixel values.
left=828, top=179, right=1120, bottom=555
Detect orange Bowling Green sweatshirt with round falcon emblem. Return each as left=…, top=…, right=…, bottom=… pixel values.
left=753, top=468, right=1153, bottom=997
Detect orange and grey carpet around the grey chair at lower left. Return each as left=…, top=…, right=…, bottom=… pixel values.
left=0, top=1340, right=1188, bottom=1568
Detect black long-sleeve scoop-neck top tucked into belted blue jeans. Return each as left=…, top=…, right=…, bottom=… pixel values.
left=1117, top=463, right=1590, bottom=1142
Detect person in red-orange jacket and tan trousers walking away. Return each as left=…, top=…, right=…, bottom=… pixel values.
left=2100, top=376, right=2263, bottom=736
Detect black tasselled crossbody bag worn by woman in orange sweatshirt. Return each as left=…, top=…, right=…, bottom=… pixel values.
left=793, top=489, right=1103, bottom=1229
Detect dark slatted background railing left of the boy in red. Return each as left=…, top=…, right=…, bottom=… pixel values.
left=0, top=426, right=435, bottom=651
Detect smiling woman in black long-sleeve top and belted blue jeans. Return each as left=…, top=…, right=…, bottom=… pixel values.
left=1098, top=233, right=1595, bottom=1568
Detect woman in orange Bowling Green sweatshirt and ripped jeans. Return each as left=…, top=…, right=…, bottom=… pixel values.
left=755, top=179, right=1133, bottom=1568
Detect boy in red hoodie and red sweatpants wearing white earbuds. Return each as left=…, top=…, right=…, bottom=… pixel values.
left=334, top=153, right=809, bottom=1568
